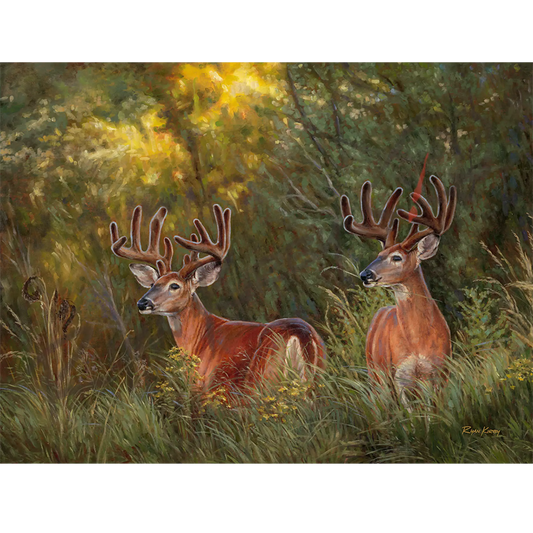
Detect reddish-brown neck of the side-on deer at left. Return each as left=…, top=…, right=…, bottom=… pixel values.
left=168, top=294, right=212, bottom=356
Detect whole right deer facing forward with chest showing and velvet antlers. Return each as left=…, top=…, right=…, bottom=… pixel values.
left=341, top=176, right=457, bottom=402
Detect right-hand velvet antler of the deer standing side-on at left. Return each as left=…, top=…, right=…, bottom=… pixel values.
left=174, top=204, right=231, bottom=279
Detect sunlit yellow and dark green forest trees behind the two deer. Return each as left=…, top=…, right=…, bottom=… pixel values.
left=0, top=59, right=533, bottom=466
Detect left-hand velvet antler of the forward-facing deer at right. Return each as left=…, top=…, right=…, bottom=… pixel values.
left=341, top=181, right=403, bottom=249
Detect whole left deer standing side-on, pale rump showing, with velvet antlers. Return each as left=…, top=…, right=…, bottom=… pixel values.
left=110, top=205, right=325, bottom=392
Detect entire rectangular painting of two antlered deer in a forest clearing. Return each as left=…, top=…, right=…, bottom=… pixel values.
left=0, top=59, right=533, bottom=467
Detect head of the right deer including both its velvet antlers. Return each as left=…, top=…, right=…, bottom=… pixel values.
left=341, top=176, right=457, bottom=287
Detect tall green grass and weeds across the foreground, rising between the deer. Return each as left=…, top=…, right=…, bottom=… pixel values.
left=0, top=237, right=533, bottom=466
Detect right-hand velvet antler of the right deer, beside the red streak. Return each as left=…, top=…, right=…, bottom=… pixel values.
left=398, top=176, right=457, bottom=250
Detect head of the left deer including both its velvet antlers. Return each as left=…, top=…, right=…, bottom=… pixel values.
left=110, top=205, right=231, bottom=316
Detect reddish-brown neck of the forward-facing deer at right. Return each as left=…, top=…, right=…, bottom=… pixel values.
left=393, top=266, right=445, bottom=345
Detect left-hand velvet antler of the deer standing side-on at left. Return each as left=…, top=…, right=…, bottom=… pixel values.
left=109, top=205, right=174, bottom=276
